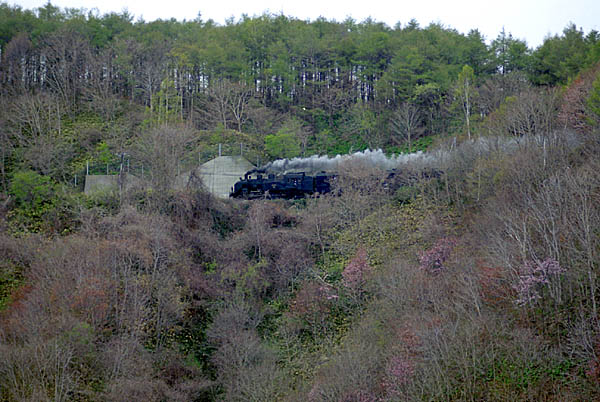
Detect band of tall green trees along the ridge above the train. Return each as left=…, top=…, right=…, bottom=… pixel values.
left=0, top=3, right=600, bottom=165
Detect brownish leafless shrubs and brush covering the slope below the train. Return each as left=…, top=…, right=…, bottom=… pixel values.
left=0, top=84, right=600, bottom=401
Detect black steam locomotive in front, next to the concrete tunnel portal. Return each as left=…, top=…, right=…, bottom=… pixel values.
left=229, top=170, right=335, bottom=199
